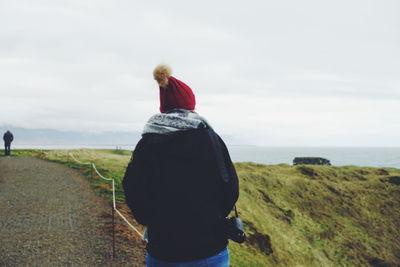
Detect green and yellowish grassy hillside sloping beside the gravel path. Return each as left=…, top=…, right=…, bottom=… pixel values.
left=12, top=150, right=400, bottom=266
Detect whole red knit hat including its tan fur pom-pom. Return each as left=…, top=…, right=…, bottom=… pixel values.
left=153, top=65, right=196, bottom=113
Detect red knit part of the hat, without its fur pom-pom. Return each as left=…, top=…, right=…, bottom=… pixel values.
left=160, top=76, right=196, bottom=113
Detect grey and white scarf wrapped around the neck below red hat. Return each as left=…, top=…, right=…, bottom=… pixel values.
left=142, top=109, right=211, bottom=134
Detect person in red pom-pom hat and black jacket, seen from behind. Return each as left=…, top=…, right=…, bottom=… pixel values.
left=123, top=65, right=239, bottom=267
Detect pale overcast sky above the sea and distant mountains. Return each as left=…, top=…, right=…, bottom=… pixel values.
left=0, top=0, right=400, bottom=146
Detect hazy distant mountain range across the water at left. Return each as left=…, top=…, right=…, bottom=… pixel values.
left=0, top=126, right=141, bottom=145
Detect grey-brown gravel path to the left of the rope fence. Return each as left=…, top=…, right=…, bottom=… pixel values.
left=0, top=157, right=144, bottom=266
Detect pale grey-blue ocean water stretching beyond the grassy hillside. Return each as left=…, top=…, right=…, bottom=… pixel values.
left=14, top=144, right=400, bottom=168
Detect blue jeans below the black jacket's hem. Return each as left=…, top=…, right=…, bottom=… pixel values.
left=146, top=248, right=229, bottom=267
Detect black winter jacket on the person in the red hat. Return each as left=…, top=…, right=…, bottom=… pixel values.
left=123, top=128, right=239, bottom=261
